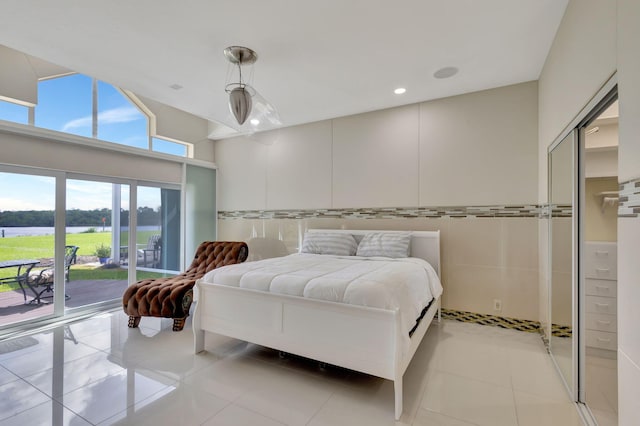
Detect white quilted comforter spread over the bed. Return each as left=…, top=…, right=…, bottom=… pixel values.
left=201, top=253, right=442, bottom=333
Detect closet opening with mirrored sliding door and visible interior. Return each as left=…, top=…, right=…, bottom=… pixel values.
left=547, top=87, right=618, bottom=426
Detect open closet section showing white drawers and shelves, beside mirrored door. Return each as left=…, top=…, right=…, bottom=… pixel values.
left=579, top=102, right=618, bottom=426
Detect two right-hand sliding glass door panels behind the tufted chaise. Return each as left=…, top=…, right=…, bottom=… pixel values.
left=65, top=179, right=180, bottom=308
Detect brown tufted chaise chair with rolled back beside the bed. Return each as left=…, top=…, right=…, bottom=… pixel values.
left=122, top=241, right=249, bottom=331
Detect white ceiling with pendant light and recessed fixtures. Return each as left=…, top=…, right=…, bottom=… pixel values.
left=0, top=0, right=568, bottom=137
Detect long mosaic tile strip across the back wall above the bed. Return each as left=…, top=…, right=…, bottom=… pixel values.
left=218, top=204, right=571, bottom=219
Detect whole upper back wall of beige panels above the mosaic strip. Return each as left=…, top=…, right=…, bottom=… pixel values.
left=215, top=82, right=538, bottom=210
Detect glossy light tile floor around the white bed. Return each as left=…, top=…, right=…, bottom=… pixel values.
left=0, top=312, right=582, bottom=426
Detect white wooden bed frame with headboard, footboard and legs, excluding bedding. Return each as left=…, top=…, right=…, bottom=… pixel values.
left=193, top=229, right=440, bottom=420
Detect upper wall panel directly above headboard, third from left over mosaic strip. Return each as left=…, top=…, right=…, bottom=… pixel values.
left=331, top=104, right=420, bottom=208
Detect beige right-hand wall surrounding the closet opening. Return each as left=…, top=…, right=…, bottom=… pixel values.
left=539, top=0, right=640, bottom=425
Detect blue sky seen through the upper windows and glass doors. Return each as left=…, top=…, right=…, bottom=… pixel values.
left=0, top=74, right=184, bottom=211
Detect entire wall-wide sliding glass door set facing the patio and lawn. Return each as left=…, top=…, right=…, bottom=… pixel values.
left=0, top=166, right=192, bottom=332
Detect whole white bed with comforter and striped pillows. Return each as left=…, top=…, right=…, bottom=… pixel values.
left=193, top=229, right=442, bottom=419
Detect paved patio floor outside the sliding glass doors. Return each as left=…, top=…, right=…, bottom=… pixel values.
left=0, top=280, right=127, bottom=326
